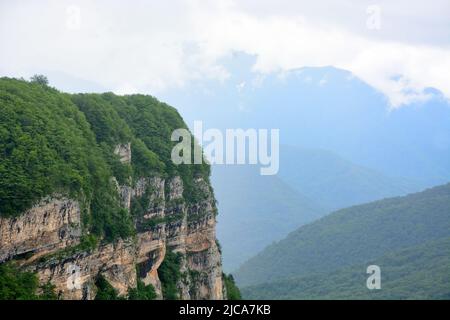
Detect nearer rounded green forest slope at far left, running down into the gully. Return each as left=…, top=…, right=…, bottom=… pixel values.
left=0, top=78, right=132, bottom=240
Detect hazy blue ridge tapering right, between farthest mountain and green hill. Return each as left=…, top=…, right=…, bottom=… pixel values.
left=279, top=145, right=423, bottom=209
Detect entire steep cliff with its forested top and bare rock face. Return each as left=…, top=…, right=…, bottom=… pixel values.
left=0, top=79, right=225, bottom=299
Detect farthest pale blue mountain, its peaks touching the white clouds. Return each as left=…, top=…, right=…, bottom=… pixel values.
left=162, top=53, right=450, bottom=186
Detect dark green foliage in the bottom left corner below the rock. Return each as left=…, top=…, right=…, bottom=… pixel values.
left=0, top=263, right=57, bottom=300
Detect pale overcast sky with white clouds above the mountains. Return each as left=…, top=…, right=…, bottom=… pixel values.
left=0, top=0, right=450, bottom=107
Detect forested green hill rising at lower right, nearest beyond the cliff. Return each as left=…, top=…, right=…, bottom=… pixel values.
left=235, top=184, right=450, bottom=299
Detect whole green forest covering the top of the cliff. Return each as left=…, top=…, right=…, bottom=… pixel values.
left=0, top=77, right=209, bottom=241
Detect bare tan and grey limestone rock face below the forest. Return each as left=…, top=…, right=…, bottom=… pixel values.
left=0, top=172, right=224, bottom=299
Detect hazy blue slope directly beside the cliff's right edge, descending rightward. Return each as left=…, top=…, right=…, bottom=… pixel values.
left=212, top=166, right=326, bottom=271
